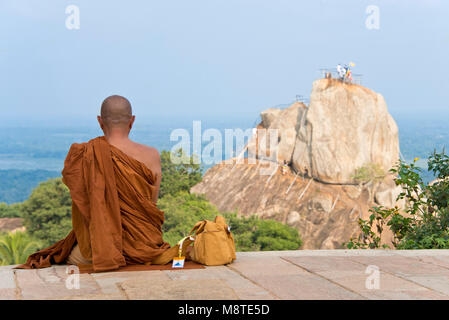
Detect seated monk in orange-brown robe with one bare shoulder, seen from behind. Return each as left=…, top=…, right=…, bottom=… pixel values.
left=18, top=95, right=188, bottom=272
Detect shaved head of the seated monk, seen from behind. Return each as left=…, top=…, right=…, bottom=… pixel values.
left=101, top=95, right=133, bottom=127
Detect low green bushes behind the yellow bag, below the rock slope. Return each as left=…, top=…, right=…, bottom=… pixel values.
left=159, top=192, right=302, bottom=251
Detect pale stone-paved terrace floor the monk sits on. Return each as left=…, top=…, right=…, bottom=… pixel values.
left=0, top=250, right=449, bottom=300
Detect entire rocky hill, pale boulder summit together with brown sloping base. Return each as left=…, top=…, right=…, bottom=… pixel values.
left=191, top=79, right=400, bottom=249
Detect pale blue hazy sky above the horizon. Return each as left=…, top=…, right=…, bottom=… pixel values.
left=0, top=0, right=449, bottom=123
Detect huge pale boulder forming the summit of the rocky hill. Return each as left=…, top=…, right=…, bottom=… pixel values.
left=250, top=79, right=399, bottom=184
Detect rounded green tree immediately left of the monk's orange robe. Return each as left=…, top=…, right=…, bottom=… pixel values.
left=22, top=178, right=72, bottom=246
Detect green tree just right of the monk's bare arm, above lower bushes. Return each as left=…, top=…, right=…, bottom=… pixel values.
left=159, top=149, right=203, bottom=198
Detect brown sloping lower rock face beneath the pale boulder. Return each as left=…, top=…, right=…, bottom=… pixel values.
left=191, top=163, right=369, bottom=249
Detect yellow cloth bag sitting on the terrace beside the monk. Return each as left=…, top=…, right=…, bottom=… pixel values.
left=190, top=216, right=236, bottom=266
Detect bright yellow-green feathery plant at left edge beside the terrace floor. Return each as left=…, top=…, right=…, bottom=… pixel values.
left=0, top=231, right=41, bottom=265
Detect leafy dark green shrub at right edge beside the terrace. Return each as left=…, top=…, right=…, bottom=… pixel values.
left=347, top=151, right=449, bottom=249
